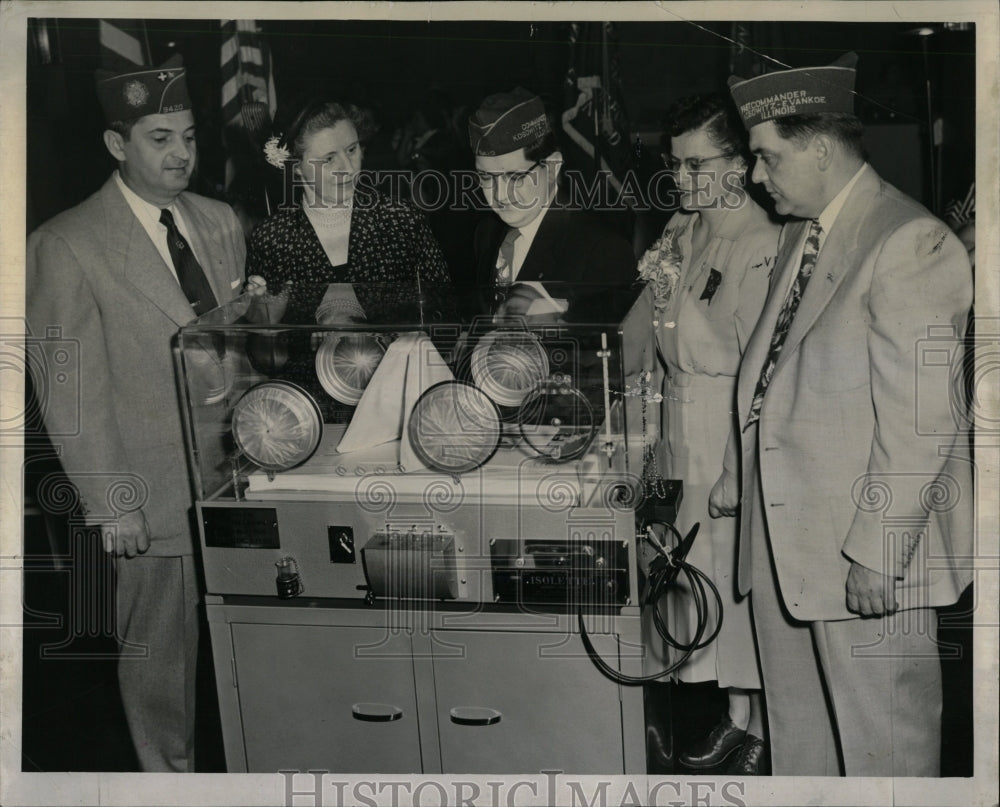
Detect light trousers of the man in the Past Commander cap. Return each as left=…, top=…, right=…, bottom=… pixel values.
left=743, top=468, right=941, bottom=776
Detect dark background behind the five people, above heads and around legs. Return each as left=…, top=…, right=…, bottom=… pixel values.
left=21, top=19, right=975, bottom=776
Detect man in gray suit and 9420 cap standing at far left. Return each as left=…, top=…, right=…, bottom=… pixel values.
left=27, top=57, right=245, bottom=771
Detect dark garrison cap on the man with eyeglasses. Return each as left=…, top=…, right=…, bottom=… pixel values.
left=469, top=87, right=551, bottom=157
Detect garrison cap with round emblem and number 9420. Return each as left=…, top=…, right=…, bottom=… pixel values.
left=96, top=54, right=191, bottom=124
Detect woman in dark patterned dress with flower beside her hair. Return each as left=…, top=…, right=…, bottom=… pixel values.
left=246, top=101, right=452, bottom=323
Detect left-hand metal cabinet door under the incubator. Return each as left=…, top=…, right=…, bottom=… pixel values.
left=232, top=624, right=421, bottom=773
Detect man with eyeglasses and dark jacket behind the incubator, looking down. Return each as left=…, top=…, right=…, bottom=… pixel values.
left=469, top=87, right=635, bottom=321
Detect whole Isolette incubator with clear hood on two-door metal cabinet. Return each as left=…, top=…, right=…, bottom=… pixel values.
left=177, top=286, right=680, bottom=773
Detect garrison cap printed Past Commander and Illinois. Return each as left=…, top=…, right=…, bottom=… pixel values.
left=729, top=53, right=858, bottom=129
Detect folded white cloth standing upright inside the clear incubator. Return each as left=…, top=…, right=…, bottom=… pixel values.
left=337, top=333, right=455, bottom=471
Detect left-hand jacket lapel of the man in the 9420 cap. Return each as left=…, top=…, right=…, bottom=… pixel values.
left=101, top=177, right=194, bottom=325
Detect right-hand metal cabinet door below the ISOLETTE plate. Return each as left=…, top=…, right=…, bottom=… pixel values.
left=434, top=631, right=624, bottom=774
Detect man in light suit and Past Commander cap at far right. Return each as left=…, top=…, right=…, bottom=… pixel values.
left=730, top=54, right=972, bottom=776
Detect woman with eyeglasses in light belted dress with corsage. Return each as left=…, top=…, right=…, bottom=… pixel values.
left=639, top=95, right=779, bottom=775
